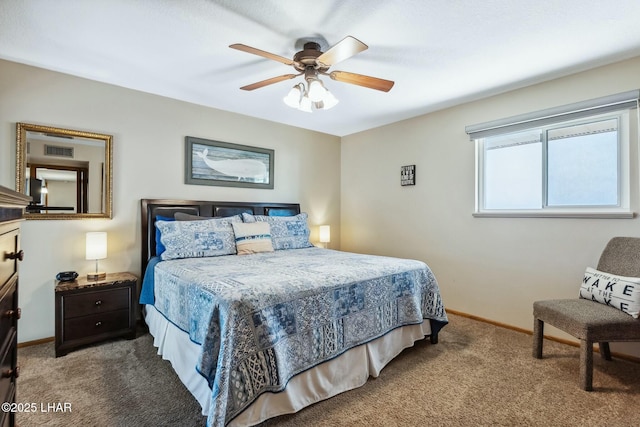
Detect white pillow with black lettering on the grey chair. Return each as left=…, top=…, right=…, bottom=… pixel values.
left=580, top=267, right=640, bottom=319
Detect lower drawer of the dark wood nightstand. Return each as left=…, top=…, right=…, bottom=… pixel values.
left=63, top=309, right=129, bottom=341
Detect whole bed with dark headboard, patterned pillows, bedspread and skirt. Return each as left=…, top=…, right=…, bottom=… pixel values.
left=140, top=199, right=448, bottom=426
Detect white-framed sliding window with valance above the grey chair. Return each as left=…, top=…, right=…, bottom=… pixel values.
left=467, top=91, right=638, bottom=217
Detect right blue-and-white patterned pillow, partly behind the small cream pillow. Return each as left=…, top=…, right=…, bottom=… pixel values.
left=242, top=213, right=313, bottom=251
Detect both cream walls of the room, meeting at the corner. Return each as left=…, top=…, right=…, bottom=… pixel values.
left=5, top=58, right=640, bottom=355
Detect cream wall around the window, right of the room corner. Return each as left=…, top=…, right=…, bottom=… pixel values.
left=341, top=58, right=640, bottom=356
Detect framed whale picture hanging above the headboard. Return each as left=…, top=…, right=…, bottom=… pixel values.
left=184, top=136, right=275, bottom=189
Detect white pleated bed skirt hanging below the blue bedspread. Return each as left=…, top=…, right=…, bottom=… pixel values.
left=145, top=305, right=431, bottom=426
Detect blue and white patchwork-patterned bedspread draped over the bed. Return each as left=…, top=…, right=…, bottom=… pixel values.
left=143, top=248, right=448, bottom=426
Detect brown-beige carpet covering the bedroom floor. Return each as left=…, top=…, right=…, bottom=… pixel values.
left=17, top=315, right=640, bottom=427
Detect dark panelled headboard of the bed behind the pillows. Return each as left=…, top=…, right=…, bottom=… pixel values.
left=140, top=199, right=300, bottom=274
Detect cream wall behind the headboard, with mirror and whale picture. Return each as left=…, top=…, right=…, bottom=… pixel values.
left=0, top=60, right=340, bottom=342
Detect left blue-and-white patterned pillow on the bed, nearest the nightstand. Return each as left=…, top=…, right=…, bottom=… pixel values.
left=156, top=215, right=242, bottom=260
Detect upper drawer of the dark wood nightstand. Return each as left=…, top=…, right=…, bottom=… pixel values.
left=63, top=287, right=131, bottom=319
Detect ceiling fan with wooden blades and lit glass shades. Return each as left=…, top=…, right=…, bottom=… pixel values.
left=229, top=36, right=394, bottom=111
